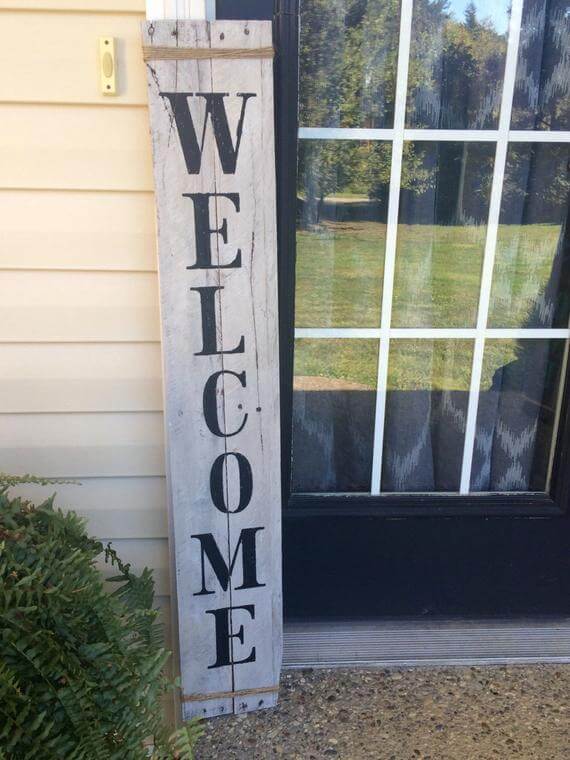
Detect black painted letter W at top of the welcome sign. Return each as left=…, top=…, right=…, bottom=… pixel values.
left=160, top=92, right=256, bottom=174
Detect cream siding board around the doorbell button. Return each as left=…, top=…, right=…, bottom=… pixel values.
left=0, top=11, right=146, bottom=107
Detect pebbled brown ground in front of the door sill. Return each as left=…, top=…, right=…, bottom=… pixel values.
left=196, top=665, right=570, bottom=760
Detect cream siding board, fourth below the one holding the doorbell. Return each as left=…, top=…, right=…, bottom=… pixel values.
left=0, top=343, right=162, bottom=413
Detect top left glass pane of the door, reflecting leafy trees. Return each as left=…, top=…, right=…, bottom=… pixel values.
left=299, top=0, right=400, bottom=129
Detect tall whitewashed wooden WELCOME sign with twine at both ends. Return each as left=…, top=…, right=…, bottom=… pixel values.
left=143, top=21, right=282, bottom=718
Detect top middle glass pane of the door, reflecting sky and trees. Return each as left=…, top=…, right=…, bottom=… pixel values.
left=407, top=0, right=510, bottom=129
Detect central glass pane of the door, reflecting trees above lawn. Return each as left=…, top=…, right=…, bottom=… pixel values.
left=392, top=142, right=495, bottom=327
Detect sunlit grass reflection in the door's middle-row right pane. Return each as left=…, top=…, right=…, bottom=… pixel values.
left=489, top=224, right=560, bottom=327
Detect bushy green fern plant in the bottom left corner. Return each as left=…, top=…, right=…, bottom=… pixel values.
left=0, top=475, right=201, bottom=760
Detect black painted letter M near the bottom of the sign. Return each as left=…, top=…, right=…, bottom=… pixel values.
left=191, top=528, right=265, bottom=596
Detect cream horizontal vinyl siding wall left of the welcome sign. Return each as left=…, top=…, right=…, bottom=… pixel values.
left=0, top=0, right=169, bottom=606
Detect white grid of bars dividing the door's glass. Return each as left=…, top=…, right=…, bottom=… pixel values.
left=295, top=0, right=570, bottom=495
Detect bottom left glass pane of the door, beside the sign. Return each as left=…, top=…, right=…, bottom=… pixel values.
left=292, top=339, right=378, bottom=492
